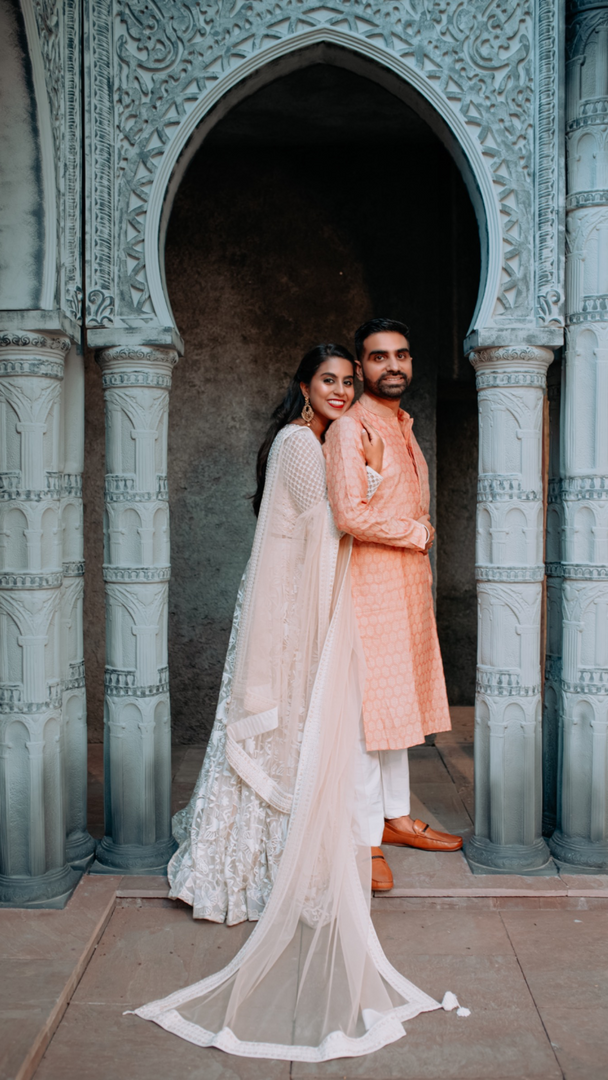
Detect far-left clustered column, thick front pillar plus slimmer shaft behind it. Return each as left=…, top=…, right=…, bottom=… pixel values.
left=0, top=332, right=93, bottom=903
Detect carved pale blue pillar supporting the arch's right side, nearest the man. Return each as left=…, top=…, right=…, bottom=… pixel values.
left=465, top=346, right=554, bottom=874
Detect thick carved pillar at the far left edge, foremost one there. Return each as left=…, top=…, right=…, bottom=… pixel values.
left=0, top=332, right=79, bottom=906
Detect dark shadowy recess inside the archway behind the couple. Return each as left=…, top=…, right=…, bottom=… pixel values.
left=165, top=65, right=479, bottom=743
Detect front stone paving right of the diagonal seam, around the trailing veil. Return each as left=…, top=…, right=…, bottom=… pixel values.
left=36, top=900, right=608, bottom=1080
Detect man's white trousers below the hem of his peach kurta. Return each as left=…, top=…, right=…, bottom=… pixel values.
left=355, top=723, right=409, bottom=848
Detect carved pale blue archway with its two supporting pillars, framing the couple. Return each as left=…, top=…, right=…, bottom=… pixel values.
left=86, top=0, right=563, bottom=870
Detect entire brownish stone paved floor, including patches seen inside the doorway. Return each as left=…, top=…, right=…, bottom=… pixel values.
left=0, top=710, right=608, bottom=1080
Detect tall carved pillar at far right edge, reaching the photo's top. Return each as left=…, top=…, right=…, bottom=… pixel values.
left=551, top=0, right=608, bottom=873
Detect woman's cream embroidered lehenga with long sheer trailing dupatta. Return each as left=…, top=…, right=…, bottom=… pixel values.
left=136, top=424, right=441, bottom=1062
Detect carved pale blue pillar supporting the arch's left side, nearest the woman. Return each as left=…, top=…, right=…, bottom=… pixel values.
left=94, top=346, right=177, bottom=874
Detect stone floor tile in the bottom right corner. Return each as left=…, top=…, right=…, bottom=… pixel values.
left=540, top=1007, right=608, bottom=1080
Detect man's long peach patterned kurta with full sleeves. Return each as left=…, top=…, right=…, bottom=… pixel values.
left=325, top=402, right=450, bottom=751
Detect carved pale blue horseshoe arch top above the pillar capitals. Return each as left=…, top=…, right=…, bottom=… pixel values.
left=86, top=0, right=563, bottom=347
